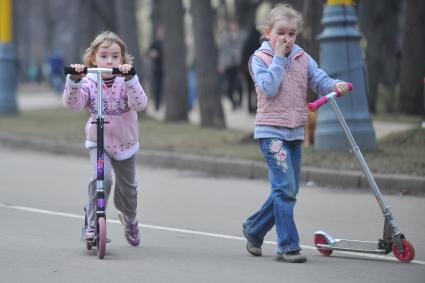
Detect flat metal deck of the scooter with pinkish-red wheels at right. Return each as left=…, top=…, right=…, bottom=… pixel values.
left=317, top=239, right=386, bottom=254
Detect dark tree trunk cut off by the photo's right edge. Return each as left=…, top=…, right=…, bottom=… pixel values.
left=399, top=0, right=425, bottom=115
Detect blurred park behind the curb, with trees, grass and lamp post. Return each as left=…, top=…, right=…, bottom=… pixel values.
left=0, top=0, right=425, bottom=193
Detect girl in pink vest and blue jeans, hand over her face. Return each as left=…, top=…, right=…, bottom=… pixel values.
left=242, top=4, right=349, bottom=263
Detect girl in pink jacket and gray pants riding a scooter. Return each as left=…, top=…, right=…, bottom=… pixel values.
left=63, top=31, right=148, bottom=246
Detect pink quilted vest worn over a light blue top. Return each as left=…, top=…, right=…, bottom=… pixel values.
left=249, top=50, right=308, bottom=128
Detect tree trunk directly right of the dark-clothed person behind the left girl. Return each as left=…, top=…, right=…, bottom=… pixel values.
left=161, top=0, right=189, bottom=121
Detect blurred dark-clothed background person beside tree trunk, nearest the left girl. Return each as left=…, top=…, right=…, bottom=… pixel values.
left=148, top=25, right=164, bottom=111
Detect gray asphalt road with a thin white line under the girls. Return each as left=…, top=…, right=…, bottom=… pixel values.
left=0, top=147, right=425, bottom=283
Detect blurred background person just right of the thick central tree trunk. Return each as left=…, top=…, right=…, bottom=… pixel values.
left=218, top=18, right=245, bottom=110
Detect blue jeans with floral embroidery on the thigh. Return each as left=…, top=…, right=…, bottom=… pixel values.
left=244, top=138, right=302, bottom=253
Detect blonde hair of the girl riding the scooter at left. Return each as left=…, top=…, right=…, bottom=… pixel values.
left=83, top=31, right=134, bottom=67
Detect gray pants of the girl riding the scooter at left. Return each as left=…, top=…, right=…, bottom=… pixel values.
left=86, top=148, right=137, bottom=226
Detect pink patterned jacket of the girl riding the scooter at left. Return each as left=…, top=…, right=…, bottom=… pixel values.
left=63, top=74, right=148, bottom=160
